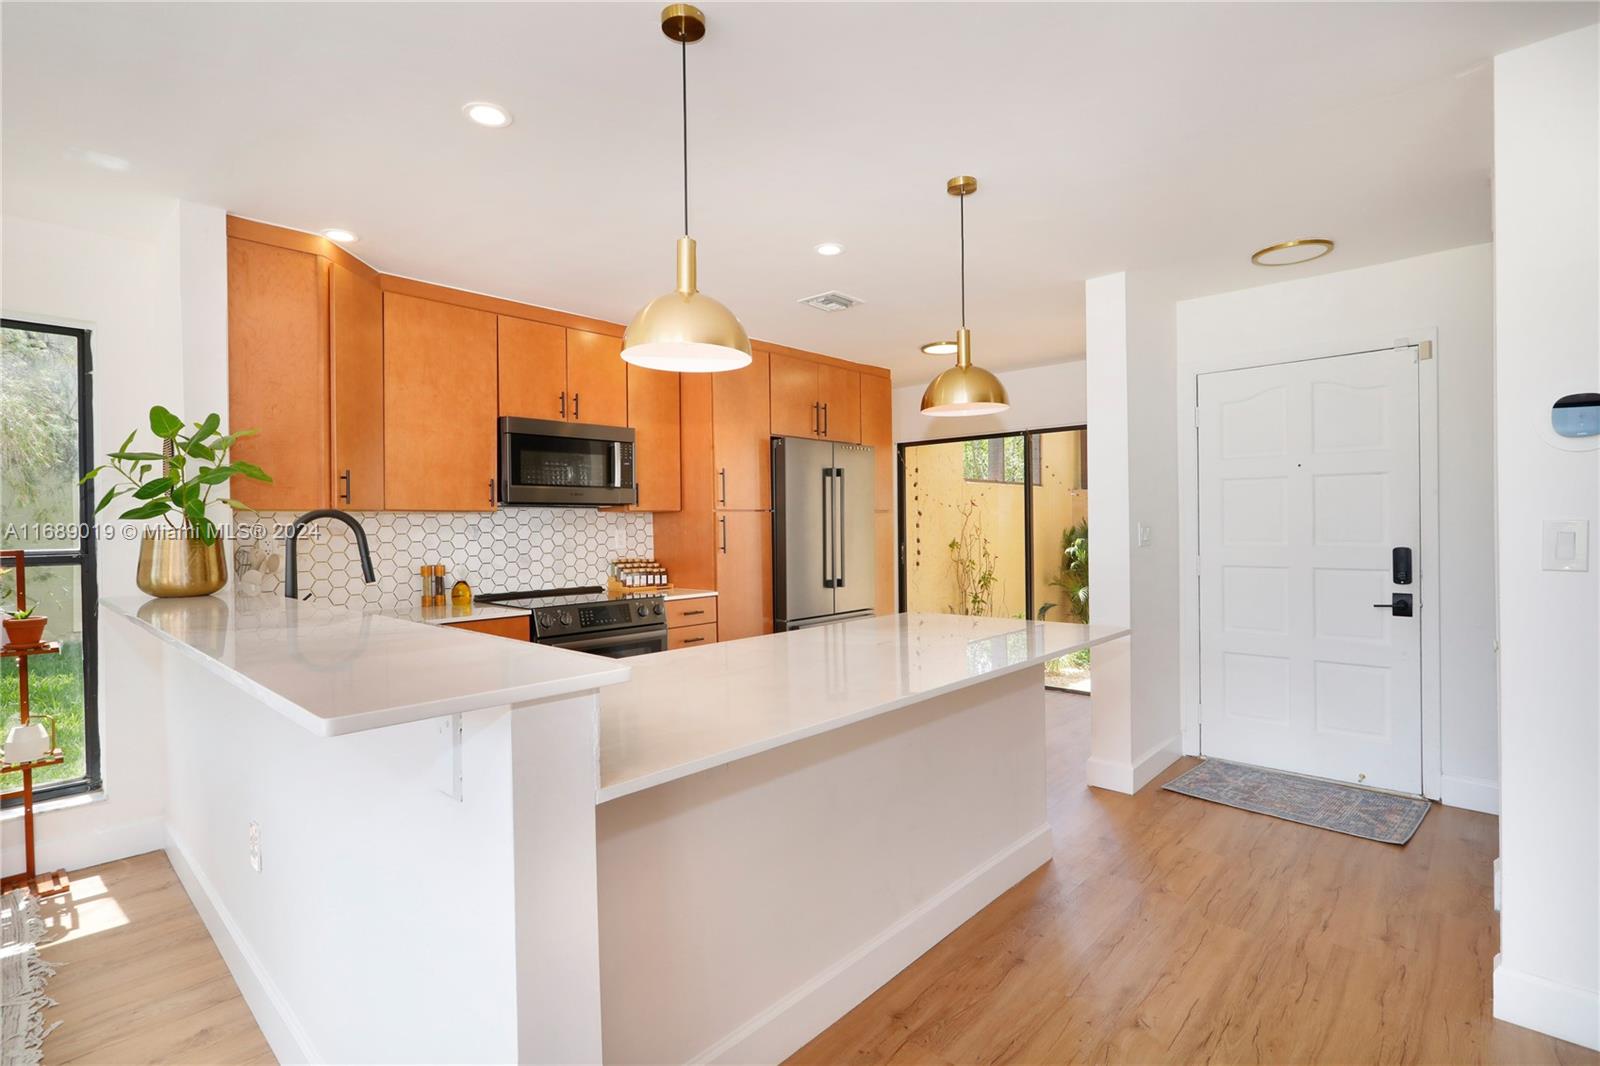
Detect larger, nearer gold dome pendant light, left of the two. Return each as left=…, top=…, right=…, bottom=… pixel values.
left=622, top=3, right=750, bottom=373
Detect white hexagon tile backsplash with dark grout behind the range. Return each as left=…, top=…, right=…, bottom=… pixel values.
left=234, top=507, right=654, bottom=608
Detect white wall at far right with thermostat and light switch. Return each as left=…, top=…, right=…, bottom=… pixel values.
left=1494, top=26, right=1600, bottom=1048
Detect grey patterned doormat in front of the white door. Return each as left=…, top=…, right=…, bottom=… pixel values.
left=1162, top=759, right=1429, bottom=844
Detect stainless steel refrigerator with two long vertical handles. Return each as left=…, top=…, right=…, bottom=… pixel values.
left=773, top=437, right=878, bottom=632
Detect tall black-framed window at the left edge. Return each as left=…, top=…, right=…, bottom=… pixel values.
left=0, top=319, right=101, bottom=802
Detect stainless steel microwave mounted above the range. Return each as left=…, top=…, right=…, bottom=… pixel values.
left=499, top=418, right=638, bottom=507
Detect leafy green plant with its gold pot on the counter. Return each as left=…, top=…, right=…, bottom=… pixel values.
left=83, top=407, right=272, bottom=597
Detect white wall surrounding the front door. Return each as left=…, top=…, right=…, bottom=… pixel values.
left=1174, top=245, right=1499, bottom=812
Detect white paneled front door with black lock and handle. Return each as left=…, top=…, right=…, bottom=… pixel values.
left=1198, top=347, right=1427, bottom=792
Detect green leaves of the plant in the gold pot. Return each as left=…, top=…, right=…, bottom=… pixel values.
left=83, top=405, right=272, bottom=544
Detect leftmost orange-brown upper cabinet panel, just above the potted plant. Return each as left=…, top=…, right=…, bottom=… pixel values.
left=225, top=237, right=331, bottom=511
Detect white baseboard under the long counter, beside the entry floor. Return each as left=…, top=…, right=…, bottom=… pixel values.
left=690, top=824, right=1051, bottom=1063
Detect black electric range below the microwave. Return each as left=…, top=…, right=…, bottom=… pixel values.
left=474, top=584, right=667, bottom=659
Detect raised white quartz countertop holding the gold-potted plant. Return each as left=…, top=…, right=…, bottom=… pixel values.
left=101, top=585, right=629, bottom=736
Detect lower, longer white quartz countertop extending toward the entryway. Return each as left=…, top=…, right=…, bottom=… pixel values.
left=597, top=615, right=1130, bottom=804
